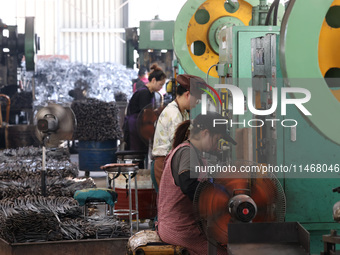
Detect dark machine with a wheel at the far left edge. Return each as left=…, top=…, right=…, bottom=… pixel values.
left=0, top=17, right=40, bottom=148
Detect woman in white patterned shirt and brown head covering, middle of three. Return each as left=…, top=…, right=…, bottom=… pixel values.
left=152, top=74, right=206, bottom=190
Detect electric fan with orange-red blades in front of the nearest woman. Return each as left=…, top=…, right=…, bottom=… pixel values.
left=194, top=161, right=286, bottom=251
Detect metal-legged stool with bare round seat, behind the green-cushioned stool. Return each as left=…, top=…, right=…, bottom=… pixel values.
left=100, top=163, right=139, bottom=235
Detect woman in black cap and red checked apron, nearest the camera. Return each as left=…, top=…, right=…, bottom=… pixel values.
left=157, top=112, right=236, bottom=255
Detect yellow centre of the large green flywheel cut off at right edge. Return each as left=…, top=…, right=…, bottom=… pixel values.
left=319, top=0, right=340, bottom=101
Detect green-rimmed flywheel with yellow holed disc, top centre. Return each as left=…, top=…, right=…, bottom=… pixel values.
left=173, top=0, right=284, bottom=80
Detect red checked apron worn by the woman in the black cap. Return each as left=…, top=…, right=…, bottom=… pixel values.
left=157, top=142, right=227, bottom=255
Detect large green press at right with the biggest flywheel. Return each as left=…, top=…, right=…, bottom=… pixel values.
left=218, top=0, right=340, bottom=254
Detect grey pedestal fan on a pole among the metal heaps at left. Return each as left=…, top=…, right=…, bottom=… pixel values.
left=34, top=104, right=76, bottom=196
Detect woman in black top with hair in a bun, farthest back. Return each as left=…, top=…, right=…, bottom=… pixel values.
left=123, top=64, right=166, bottom=152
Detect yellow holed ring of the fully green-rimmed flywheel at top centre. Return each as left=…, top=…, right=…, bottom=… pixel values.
left=186, top=0, right=252, bottom=78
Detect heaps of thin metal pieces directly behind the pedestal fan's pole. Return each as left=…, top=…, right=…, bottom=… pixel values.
left=0, top=147, right=96, bottom=199
